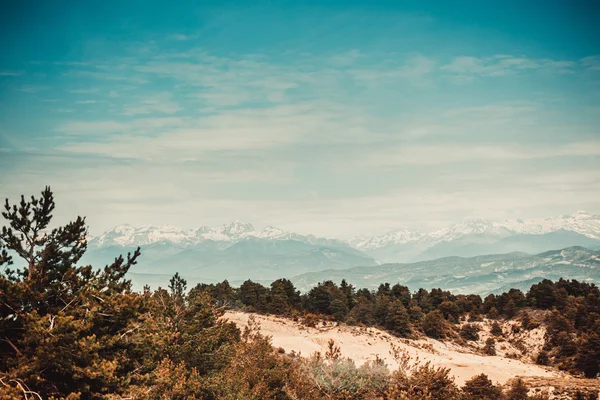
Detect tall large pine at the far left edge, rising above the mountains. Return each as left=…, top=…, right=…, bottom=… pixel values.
left=0, top=187, right=140, bottom=398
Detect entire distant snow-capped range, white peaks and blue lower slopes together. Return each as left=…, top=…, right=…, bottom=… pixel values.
left=82, top=211, right=600, bottom=290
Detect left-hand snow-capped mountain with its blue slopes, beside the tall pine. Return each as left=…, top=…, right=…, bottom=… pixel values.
left=82, top=221, right=377, bottom=288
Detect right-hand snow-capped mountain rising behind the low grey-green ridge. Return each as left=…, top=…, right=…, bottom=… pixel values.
left=349, top=211, right=600, bottom=262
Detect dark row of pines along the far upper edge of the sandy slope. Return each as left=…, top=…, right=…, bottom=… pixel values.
left=192, top=279, right=600, bottom=377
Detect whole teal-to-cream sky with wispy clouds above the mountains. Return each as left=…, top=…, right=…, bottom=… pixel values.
left=0, top=0, right=600, bottom=238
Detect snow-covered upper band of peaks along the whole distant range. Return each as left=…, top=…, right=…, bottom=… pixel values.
left=89, top=211, right=600, bottom=250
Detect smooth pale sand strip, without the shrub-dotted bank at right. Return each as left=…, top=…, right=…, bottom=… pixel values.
left=224, top=312, right=561, bottom=385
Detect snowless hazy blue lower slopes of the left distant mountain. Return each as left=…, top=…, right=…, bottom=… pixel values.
left=82, top=233, right=376, bottom=289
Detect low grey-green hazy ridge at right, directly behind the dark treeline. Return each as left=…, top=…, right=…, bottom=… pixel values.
left=291, top=247, right=600, bottom=294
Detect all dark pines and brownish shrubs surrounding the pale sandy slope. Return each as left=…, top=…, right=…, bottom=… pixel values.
left=0, top=188, right=600, bottom=400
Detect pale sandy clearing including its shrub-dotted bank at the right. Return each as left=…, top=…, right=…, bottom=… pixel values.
left=224, top=312, right=570, bottom=386
